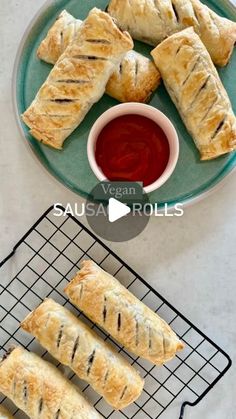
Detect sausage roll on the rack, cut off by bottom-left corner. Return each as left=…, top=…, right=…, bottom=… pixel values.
left=0, top=347, right=101, bottom=419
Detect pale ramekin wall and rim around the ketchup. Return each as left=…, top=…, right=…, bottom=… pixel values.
left=87, top=103, right=179, bottom=193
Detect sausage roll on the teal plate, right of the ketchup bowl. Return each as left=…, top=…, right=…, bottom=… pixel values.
left=151, top=28, right=236, bottom=160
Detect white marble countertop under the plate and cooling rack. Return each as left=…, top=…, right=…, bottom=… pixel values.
left=0, top=0, right=236, bottom=419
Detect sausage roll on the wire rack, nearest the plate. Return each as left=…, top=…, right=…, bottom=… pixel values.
left=65, top=260, right=183, bottom=365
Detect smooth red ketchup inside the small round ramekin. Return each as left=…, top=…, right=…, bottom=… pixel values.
left=95, top=115, right=170, bottom=186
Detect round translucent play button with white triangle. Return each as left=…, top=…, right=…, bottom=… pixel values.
left=85, top=180, right=150, bottom=242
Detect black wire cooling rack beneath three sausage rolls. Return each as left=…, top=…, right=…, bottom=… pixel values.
left=0, top=207, right=231, bottom=419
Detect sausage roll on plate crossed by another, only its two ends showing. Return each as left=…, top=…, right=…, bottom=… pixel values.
left=37, top=10, right=161, bottom=102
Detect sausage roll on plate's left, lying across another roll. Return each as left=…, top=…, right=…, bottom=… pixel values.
left=23, top=8, right=133, bottom=149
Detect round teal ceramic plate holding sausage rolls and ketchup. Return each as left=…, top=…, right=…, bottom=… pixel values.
left=14, top=0, right=236, bottom=207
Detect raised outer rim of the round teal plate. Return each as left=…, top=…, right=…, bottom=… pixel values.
left=11, top=0, right=236, bottom=212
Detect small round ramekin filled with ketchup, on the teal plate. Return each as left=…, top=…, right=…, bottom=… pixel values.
left=87, top=103, right=179, bottom=194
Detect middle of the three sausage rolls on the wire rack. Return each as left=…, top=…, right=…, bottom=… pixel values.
left=21, top=299, right=144, bottom=410
